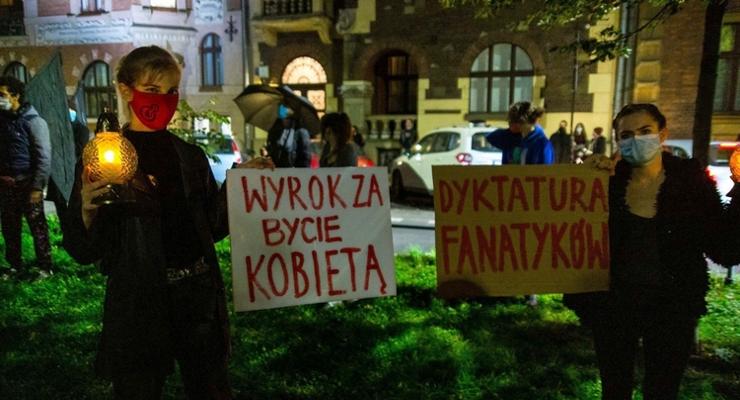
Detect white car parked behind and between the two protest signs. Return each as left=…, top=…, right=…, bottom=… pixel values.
left=391, top=127, right=502, bottom=199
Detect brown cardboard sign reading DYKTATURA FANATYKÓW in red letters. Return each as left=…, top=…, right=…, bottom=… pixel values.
left=433, top=165, right=609, bottom=297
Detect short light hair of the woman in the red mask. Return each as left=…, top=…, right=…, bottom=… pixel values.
left=116, top=46, right=182, bottom=87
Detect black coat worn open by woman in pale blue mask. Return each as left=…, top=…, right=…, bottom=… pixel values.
left=564, top=153, right=740, bottom=323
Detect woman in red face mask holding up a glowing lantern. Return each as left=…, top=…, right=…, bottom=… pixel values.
left=65, top=46, right=272, bottom=399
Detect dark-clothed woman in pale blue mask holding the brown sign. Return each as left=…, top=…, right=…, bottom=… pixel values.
left=565, top=104, right=740, bottom=400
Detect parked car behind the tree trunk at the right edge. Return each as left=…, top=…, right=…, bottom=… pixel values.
left=663, top=139, right=740, bottom=201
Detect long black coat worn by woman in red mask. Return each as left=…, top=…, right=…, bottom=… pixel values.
left=64, top=134, right=229, bottom=377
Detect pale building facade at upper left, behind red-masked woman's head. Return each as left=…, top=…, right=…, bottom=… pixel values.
left=0, top=0, right=246, bottom=140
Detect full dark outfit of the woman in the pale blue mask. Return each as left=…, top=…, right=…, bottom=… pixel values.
left=564, top=153, right=740, bottom=399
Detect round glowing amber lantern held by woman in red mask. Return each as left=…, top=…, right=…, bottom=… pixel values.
left=82, top=112, right=139, bottom=204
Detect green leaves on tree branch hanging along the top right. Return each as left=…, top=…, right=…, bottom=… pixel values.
left=439, top=0, right=686, bottom=63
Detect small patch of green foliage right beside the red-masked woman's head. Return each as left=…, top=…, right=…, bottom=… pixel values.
left=169, top=99, right=230, bottom=161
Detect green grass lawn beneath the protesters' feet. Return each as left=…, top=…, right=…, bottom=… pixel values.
left=0, top=220, right=740, bottom=400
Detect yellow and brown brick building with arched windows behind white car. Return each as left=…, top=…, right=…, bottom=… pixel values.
left=249, top=0, right=740, bottom=161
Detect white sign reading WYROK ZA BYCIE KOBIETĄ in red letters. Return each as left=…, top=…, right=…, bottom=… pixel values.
left=226, top=168, right=396, bottom=311
